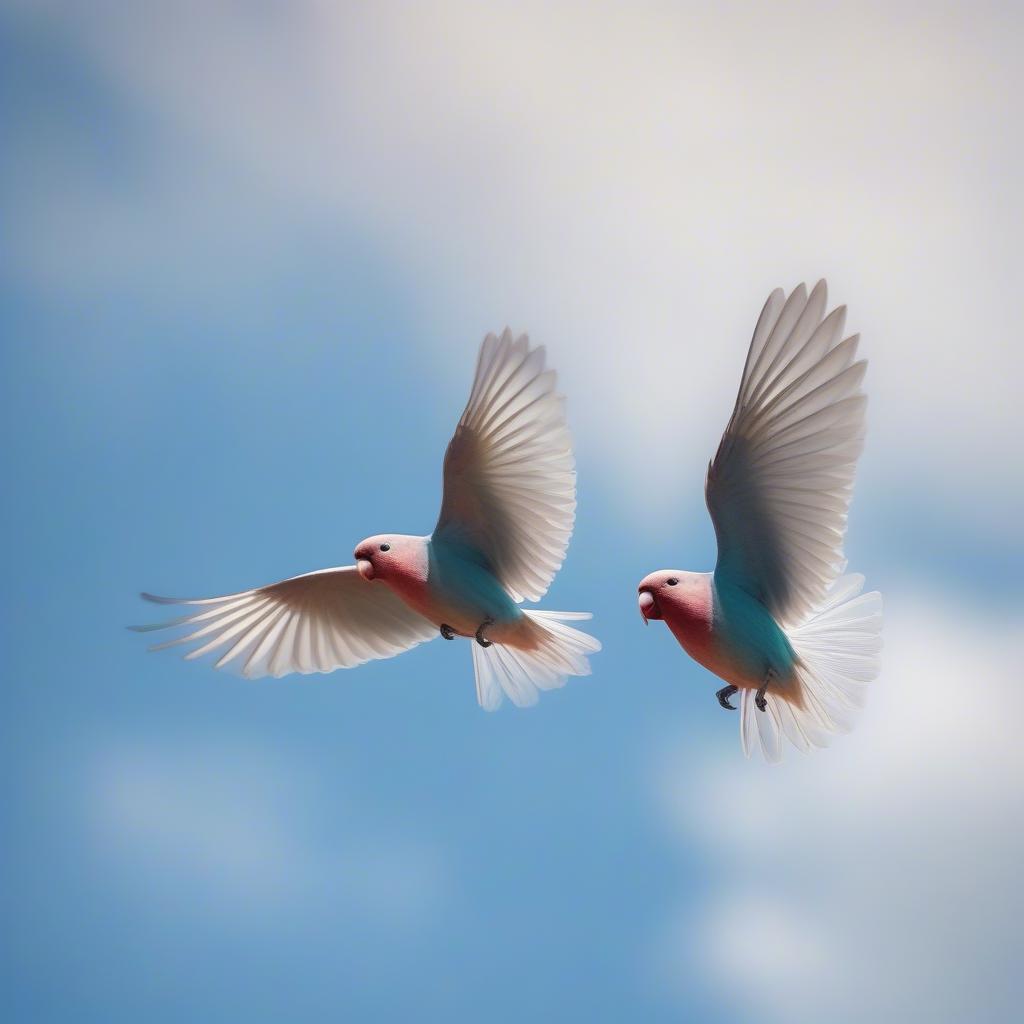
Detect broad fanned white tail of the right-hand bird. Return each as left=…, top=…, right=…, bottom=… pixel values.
left=739, top=574, right=882, bottom=763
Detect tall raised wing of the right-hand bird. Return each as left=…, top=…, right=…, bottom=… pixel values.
left=706, top=281, right=867, bottom=627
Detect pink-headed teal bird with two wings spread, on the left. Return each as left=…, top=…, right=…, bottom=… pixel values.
left=132, top=329, right=601, bottom=711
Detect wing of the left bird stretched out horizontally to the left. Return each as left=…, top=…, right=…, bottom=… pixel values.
left=132, top=565, right=437, bottom=678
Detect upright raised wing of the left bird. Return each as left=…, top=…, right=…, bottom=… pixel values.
left=434, top=329, right=575, bottom=601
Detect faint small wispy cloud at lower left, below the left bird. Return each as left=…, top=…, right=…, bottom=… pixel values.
left=91, top=741, right=447, bottom=927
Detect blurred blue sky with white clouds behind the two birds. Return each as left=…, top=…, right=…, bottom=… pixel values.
left=0, top=2, right=1024, bottom=1022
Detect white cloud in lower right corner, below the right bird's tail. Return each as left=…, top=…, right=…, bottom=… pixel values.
left=657, top=592, right=1024, bottom=1022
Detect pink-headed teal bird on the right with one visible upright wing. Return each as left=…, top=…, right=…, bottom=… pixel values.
left=638, top=281, right=882, bottom=762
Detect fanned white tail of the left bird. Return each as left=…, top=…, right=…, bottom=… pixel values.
left=472, top=609, right=601, bottom=711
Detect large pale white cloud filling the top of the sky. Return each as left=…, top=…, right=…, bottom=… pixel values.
left=14, top=3, right=1024, bottom=524
